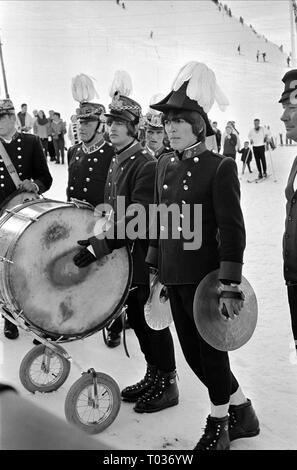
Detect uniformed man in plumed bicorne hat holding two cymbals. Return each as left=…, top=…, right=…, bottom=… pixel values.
left=147, top=62, right=259, bottom=450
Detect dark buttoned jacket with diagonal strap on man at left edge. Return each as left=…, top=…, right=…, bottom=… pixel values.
left=0, top=132, right=53, bottom=202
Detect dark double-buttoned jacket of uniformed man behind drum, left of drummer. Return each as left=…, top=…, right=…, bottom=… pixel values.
left=66, top=139, right=114, bottom=207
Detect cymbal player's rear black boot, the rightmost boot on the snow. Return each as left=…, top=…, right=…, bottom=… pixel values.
left=229, top=399, right=260, bottom=441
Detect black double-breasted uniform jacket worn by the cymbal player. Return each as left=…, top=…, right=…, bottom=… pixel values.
left=147, top=143, right=245, bottom=285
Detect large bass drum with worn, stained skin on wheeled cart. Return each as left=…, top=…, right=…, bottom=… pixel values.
left=0, top=199, right=132, bottom=342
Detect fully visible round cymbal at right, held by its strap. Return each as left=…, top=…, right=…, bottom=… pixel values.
left=193, top=269, right=258, bottom=351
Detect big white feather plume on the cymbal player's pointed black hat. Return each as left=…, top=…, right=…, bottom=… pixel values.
left=172, top=61, right=229, bottom=113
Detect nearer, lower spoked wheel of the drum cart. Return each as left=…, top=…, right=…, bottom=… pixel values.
left=65, top=372, right=121, bottom=434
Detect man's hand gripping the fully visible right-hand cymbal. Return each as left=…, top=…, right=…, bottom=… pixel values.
left=219, top=285, right=244, bottom=320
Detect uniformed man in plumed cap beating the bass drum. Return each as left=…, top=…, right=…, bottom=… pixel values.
left=74, top=73, right=178, bottom=413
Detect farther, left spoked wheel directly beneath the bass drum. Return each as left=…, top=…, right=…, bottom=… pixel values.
left=19, top=344, right=70, bottom=393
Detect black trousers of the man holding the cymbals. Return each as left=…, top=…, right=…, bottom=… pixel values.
left=168, top=284, right=239, bottom=406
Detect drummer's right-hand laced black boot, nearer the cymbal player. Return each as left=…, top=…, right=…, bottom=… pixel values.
left=134, top=370, right=178, bottom=413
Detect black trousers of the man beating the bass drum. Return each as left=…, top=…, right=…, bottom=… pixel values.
left=115, top=285, right=175, bottom=372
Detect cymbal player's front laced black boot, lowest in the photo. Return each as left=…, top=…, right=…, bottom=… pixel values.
left=194, top=415, right=230, bottom=450
